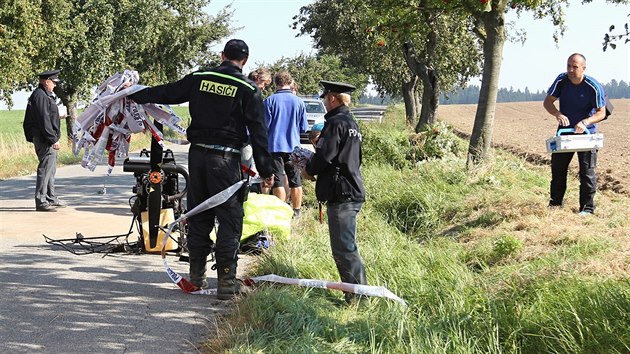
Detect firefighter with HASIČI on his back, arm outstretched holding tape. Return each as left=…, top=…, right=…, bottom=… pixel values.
left=130, top=39, right=273, bottom=300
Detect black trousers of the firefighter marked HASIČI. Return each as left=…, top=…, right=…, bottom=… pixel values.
left=187, top=145, right=244, bottom=263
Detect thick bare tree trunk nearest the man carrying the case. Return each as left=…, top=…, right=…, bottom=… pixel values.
left=466, top=9, right=505, bottom=167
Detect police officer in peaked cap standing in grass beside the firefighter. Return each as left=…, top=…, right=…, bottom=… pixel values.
left=303, top=81, right=367, bottom=303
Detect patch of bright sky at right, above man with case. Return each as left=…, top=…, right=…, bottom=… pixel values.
left=499, top=0, right=630, bottom=91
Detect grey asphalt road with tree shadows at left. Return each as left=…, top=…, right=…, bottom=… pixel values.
left=0, top=142, right=242, bottom=353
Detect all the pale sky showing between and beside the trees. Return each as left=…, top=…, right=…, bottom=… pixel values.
left=0, top=0, right=630, bottom=109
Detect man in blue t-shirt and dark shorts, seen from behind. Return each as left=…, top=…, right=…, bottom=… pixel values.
left=265, top=71, right=308, bottom=216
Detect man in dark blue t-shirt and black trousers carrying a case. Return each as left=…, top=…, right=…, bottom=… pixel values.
left=543, top=53, right=606, bottom=215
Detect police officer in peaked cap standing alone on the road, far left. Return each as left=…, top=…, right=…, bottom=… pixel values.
left=23, top=70, right=66, bottom=211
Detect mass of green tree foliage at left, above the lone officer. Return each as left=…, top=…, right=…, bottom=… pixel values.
left=0, top=0, right=232, bottom=120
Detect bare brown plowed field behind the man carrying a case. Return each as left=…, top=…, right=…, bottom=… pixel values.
left=438, top=99, right=630, bottom=194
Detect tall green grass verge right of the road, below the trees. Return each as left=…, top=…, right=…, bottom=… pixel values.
left=205, top=105, right=630, bottom=353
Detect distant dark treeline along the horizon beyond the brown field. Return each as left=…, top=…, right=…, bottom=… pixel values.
left=359, top=80, right=630, bottom=105
